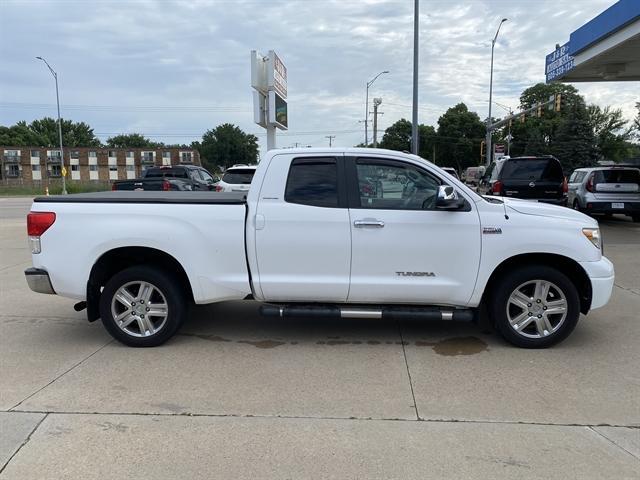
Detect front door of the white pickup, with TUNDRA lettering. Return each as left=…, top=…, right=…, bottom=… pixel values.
left=347, top=158, right=481, bottom=306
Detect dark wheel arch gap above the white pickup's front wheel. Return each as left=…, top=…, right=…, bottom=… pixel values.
left=481, top=253, right=592, bottom=314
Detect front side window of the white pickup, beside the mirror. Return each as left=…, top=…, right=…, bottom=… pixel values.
left=356, top=159, right=442, bottom=210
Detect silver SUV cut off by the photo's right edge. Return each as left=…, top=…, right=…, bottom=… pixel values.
left=569, top=167, right=640, bottom=222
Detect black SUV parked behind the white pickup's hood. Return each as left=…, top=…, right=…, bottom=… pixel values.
left=478, top=155, right=567, bottom=206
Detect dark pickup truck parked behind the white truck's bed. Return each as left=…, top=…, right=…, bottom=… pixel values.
left=111, top=165, right=217, bottom=191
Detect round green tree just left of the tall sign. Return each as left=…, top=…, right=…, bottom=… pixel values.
left=199, top=123, right=258, bottom=170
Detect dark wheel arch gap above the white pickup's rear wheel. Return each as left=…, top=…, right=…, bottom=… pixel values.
left=87, top=247, right=194, bottom=322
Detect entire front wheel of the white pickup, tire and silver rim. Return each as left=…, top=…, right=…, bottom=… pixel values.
left=489, top=266, right=580, bottom=348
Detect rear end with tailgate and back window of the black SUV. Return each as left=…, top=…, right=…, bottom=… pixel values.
left=500, top=158, right=564, bottom=200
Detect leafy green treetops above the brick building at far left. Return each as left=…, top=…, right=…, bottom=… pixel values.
left=0, top=117, right=100, bottom=147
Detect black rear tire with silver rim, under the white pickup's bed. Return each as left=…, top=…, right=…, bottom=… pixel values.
left=100, top=265, right=187, bottom=347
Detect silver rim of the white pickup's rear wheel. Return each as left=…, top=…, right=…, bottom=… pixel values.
left=111, top=281, right=169, bottom=337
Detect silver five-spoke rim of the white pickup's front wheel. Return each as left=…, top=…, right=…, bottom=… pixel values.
left=507, top=280, right=568, bottom=338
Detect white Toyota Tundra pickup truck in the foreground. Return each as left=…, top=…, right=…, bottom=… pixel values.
left=25, top=149, right=614, bottom=348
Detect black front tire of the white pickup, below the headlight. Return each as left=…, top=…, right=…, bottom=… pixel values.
left=488, top=265, right=580, bottom=348
